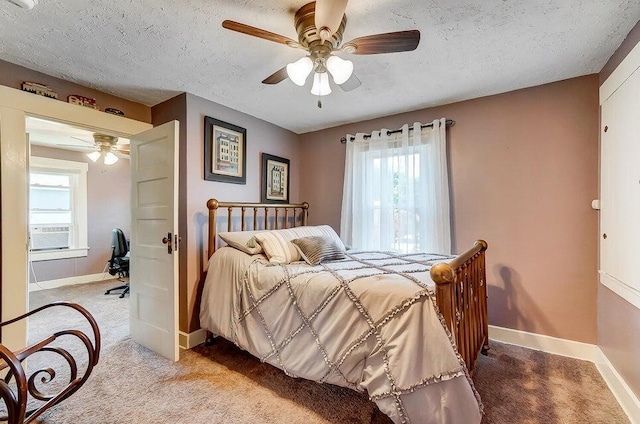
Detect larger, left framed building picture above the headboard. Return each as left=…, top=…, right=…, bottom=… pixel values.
left=204, top=116, right=247, bottom=184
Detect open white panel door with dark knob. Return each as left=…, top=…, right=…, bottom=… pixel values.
left=129, top=121, right=179, bottom=361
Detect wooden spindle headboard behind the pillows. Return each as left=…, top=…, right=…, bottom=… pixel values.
left=207, top=199, right=309, bottom=258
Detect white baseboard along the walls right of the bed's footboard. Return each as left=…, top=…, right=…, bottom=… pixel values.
left=489, top=325, right=640, bottom=424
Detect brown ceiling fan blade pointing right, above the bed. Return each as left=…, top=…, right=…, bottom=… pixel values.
left=341, top=29, right=420, bottom=54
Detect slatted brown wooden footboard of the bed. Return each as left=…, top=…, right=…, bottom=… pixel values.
left=431, top=240, right=489, bottom=373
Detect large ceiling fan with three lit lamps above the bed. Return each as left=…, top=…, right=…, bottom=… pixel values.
left=222, top=0, right=420, bottom=107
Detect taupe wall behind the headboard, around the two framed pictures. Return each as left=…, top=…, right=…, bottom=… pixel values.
left=153, top=94, right=300, bottom=332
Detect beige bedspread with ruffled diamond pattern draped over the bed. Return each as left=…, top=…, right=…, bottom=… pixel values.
left=200, top=247, right=482, bottom=424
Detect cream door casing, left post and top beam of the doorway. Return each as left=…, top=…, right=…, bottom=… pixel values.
left=0, top=86, right=152, bottom=350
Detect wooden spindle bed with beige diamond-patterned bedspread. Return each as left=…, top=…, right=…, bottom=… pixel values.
left=200, top=199, right=489, bottom=424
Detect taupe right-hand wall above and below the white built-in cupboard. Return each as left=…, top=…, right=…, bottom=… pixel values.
left=598, top=23, right=640, bottom=397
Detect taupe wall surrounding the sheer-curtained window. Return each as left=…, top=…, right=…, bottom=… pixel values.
left=300, top=75, right=598, bottom=343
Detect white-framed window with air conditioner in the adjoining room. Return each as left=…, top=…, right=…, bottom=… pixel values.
left=29, top=156, right=89, bottom=261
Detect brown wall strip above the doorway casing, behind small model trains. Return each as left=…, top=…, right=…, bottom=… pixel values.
left=0, top=60, right=151, bottom=122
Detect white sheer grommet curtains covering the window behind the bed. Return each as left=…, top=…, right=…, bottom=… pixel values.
left=340, top=118, right=451, bottom=253
